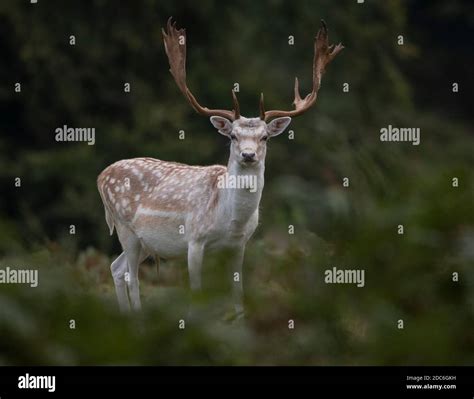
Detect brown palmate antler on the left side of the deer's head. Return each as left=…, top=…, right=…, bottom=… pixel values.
left=161, top=17, right=240, bottom=121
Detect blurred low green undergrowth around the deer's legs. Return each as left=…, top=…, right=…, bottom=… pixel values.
left=0, top=219, right=474, bottom=365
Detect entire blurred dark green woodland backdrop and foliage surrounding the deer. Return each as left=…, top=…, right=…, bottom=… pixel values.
left=0, top=0, right=474, bottom=365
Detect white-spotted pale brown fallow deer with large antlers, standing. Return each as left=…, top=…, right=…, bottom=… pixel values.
left=97, top=18, right=344, bottom=314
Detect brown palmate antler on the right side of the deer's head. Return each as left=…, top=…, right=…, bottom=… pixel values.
left=260, top=20, right=344, bottom=120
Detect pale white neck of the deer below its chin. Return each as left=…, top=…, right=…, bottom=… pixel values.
left=221, top=158, right=265, bottom=230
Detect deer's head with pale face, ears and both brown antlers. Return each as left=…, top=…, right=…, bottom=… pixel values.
left=162, top=18, right=344, bottom=167
